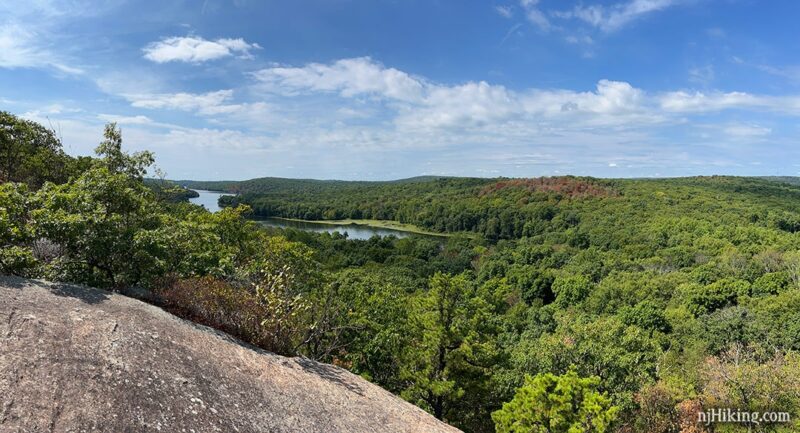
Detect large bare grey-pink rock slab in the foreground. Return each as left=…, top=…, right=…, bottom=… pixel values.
left=0, top=277, right=457, bottom=433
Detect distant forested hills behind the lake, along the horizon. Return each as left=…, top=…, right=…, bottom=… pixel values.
left=191, top=176, right=800, bottom=244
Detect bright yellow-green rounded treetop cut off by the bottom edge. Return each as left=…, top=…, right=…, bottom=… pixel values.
left=492, top=370, right=619, bottom=433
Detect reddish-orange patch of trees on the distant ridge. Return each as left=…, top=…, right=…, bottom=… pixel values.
left=478, top=177, right=618, bottom=198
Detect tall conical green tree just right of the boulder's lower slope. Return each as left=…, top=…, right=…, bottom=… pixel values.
left=401, top=273, right=502, bottom=430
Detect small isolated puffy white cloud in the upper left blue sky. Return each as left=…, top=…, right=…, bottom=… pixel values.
left=143, top=36, right=261, bottom=63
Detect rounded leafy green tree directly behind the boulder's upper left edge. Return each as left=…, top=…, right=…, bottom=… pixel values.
left=32, top=168, right=167, bottom=287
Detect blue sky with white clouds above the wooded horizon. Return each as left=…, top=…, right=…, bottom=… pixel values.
left=0, top=0, right=800, bottom=180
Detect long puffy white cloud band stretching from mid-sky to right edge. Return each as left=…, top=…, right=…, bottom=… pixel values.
left=253, top=58, right=800, bottom=135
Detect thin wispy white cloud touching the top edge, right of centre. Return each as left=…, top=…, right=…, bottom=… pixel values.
left=553, top=0, right=680, bottom=32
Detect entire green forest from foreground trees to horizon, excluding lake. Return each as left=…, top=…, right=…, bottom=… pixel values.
left=0, top=109, right=800, bottom=433
